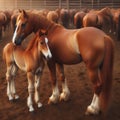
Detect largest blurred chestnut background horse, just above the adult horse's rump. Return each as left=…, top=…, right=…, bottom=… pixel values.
left=83, top=7, right=113, bottom=32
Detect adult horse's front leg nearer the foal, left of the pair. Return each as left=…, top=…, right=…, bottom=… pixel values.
left=47, top=60, right=60, bottom=104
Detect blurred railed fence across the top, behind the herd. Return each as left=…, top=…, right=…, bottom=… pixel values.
left=0, top=0, right=120, bottom=10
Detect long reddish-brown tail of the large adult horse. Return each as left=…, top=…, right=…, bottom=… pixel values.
left=100, top=36, right=114, bottom=112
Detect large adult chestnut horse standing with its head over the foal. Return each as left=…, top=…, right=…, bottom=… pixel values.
left=13, top=10, right=114, bottom=114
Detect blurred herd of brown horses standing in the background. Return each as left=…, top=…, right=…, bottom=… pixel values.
left=0, top=7, right=120, bottom=40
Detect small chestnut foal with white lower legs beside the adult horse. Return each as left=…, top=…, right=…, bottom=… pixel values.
left=3, top=31, right=52, bottom=111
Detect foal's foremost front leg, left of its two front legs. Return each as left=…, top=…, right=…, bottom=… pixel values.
left=27, top=72, right=34, bottom=112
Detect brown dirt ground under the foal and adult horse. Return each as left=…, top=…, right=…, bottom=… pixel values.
left=0, top=31, right=120, bottom=120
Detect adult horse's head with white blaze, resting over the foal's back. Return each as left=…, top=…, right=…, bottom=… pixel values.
left=12, top=10, right=32, bottom=45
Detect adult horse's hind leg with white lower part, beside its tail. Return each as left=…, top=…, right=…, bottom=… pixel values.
left=86, top=68, right=102, bottom=115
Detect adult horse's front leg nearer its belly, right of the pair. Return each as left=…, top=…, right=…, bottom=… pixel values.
left=57, top=64, right=70, bottom=101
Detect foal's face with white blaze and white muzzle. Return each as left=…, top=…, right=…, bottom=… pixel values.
left=38, top=36, right=52, bottom=59
